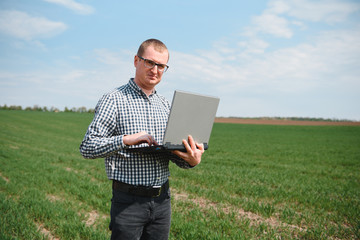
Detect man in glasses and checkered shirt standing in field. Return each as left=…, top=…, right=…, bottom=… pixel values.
left=80, top=39, right=204, bottom=240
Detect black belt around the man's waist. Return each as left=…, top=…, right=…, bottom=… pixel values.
left=112, top=180, right=169, bottom=198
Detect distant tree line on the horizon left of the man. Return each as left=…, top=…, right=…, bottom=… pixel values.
left=0, top=104, right=95, bottom=113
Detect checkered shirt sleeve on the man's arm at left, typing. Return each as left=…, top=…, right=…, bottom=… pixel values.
left=80, top=95, right=126, bottom=159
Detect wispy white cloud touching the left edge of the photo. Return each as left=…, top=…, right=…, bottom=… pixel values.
left=0, top=10, right=67, bottom=41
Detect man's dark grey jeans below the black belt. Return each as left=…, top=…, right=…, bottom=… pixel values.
left=109, top=186, right=171, bottom=240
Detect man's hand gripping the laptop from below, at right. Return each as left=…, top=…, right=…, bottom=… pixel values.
left=173, top=135, right=205, bottom=167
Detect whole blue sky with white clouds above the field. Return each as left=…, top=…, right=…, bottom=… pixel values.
left=0, top=0, right=360, bottom=121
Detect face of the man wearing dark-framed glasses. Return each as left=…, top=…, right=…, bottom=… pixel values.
left=134, top=46, right=169, bottom=91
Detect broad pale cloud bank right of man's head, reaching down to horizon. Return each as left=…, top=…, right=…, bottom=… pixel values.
left=159, top=24, right=360, bottom=119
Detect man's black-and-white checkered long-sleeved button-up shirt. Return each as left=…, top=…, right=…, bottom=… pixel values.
left=80, top=79, right=190, bottom=186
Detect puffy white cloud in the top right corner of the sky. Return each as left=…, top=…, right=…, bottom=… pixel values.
left=244, top=0, right=360, bottom=38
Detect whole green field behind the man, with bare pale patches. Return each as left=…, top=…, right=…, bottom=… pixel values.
left=0, top=110, right=360, bottom=240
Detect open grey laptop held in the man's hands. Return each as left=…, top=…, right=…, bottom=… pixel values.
left=127, top=90, right=220, bottom=152
